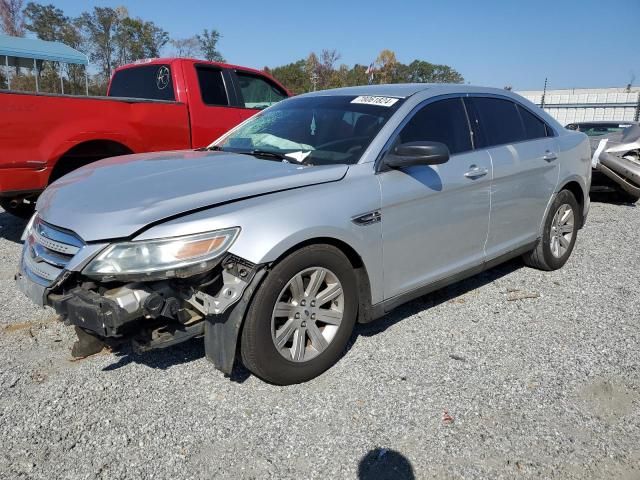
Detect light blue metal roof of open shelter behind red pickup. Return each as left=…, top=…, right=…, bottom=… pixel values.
left=0, top=35, right=89, bottom=65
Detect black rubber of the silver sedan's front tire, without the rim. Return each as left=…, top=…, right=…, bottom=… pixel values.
left=240, top=245, right=358, bottom=385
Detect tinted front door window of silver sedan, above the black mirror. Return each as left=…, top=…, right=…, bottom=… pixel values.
left=396, top=98, right=472, bottom=154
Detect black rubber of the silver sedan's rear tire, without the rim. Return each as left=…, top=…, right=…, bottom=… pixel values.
left=522, top=190, right=582, bottom=271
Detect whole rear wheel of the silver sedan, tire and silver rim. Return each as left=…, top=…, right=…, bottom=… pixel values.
left=523, top=190, right=581, bottom=270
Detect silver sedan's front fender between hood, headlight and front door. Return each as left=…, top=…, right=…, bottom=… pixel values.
left=137, top=169, right=382, bottom=303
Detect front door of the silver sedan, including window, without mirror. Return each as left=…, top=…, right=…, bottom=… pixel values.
left=378, top=97, right=491, bottom=299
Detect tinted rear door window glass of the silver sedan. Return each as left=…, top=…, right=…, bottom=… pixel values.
left=469, top=97, right=527, bottom=148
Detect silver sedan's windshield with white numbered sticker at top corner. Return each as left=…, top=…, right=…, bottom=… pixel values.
left=211, top=95, right=402, bottom=165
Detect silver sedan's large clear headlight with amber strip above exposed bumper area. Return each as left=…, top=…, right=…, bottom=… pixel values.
left=83, top=227, right=240, bottom=280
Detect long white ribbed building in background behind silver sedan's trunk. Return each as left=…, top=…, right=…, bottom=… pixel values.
left=518, top=87, right=640, bottom=125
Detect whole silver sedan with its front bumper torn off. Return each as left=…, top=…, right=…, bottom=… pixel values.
left=16, top=84, right=591, bottom=384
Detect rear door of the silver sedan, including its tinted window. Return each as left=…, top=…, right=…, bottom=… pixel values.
left=466, top=97, right=559, bottom=258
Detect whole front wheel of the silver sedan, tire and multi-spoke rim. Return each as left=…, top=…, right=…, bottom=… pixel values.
left=240, top=245, right=358, bottom=385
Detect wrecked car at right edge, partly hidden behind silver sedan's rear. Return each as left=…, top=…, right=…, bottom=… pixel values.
left=566, top=121, right=640, bottom=203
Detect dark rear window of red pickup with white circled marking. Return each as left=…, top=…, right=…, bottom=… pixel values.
left=109, top=65, right=176, bottom=101
